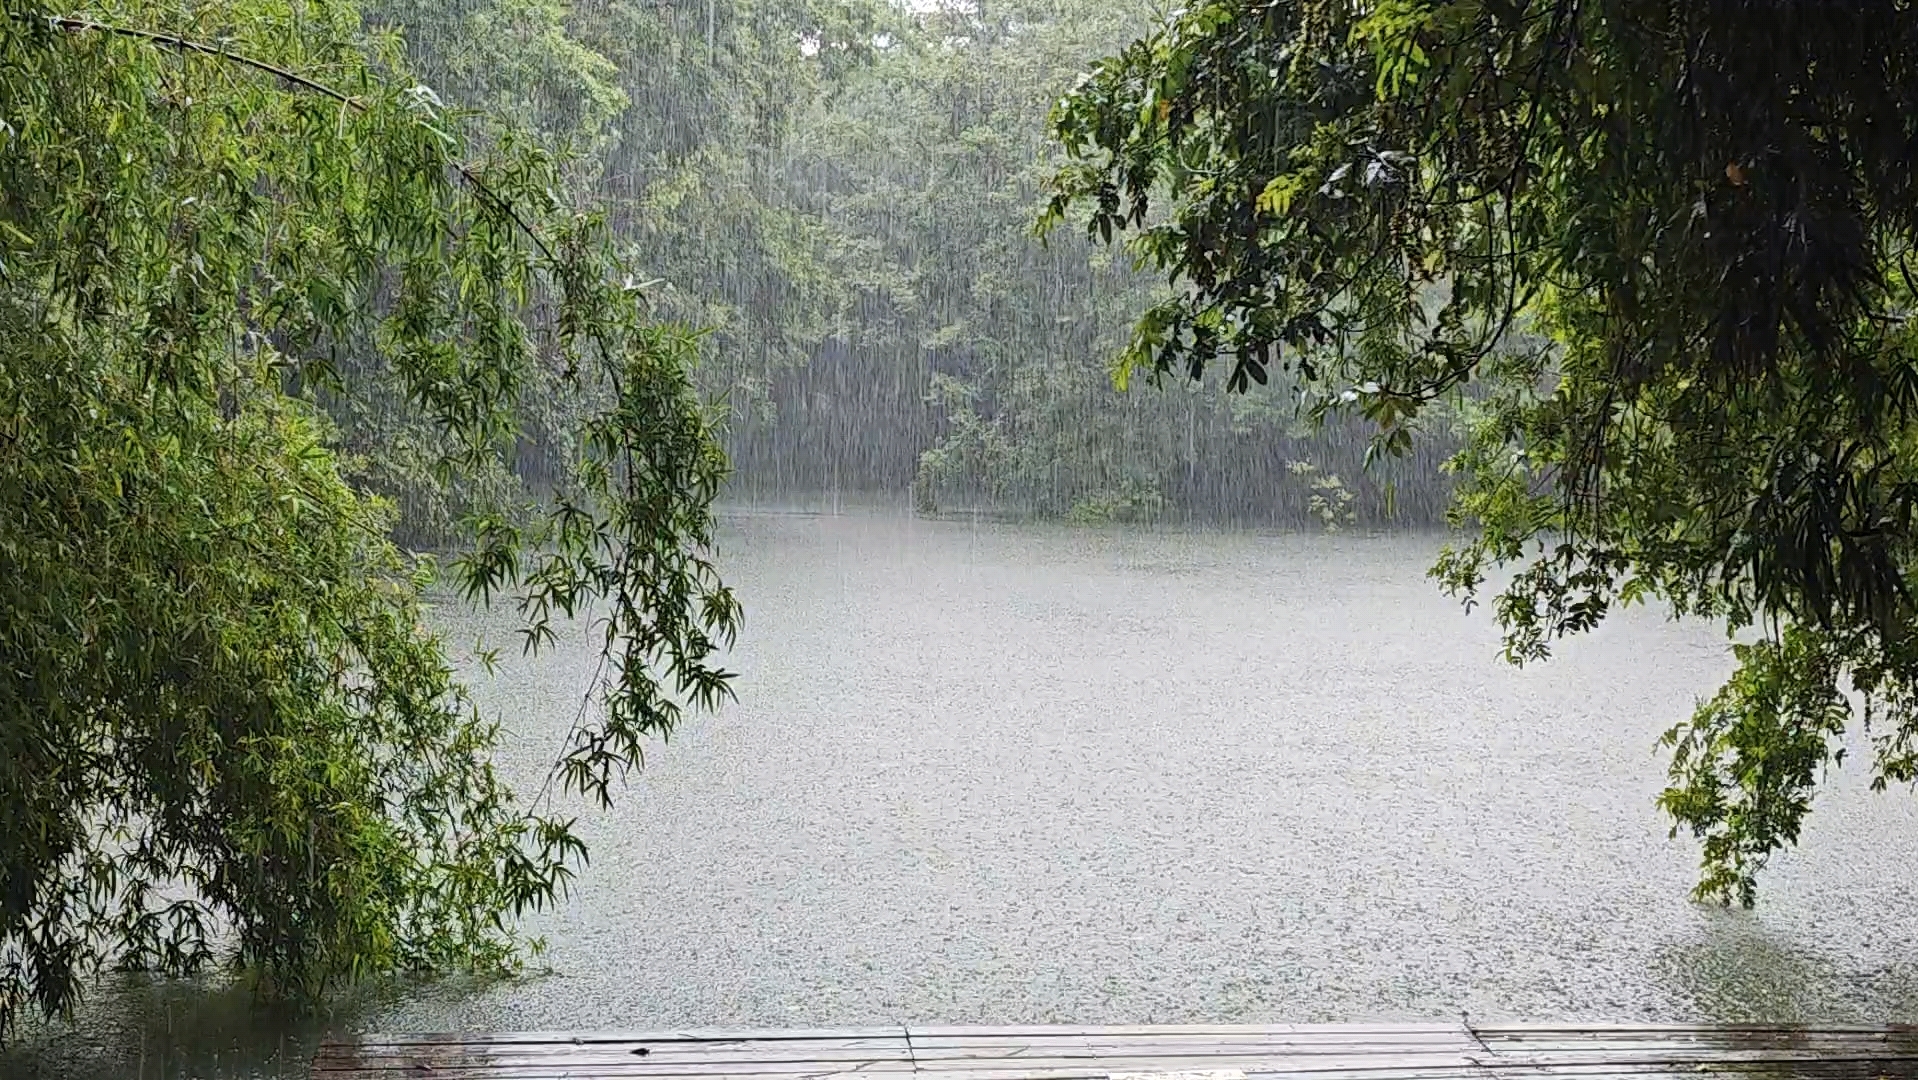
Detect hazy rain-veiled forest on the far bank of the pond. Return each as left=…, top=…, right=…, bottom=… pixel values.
left=366, top=0, right=1456, bottom=539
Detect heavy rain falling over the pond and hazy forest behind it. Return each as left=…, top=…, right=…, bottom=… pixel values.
left=11, top=0, right=1918, bottom=1080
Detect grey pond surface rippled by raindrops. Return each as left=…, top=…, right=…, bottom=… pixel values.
left=11, top=514, right=1918, bottom=1078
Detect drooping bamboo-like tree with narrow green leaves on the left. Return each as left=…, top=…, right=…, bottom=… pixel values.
left=0, top=0, right=738, bottom=1036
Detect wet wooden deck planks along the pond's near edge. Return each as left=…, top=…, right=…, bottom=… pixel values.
left=313, top=1022, right=1918, bottom=1080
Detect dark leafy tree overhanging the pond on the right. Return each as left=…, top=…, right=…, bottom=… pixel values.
left=1049, top=0, right=1918, bottom=904
